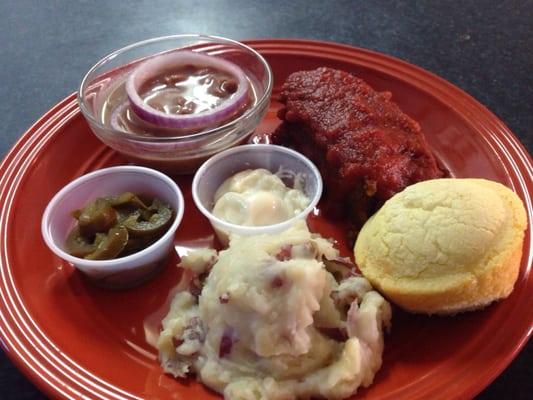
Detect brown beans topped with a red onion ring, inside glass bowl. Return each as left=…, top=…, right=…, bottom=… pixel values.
left=99, top=50, right=254, bottom=136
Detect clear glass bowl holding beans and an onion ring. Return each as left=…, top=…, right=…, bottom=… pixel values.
left=78, top=35, right=273, bottom=174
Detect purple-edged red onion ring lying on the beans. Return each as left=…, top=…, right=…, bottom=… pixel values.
left=126, top=50, right=248, bottom=129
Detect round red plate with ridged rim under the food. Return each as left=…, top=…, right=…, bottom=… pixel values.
left=0, top=40, right=533, bottom=399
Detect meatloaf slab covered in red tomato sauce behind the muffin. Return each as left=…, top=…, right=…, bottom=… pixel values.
left=271, top=68, right=445, bottom=233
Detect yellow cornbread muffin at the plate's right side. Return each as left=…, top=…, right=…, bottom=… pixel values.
left=354, top=179, right=527, bottom=314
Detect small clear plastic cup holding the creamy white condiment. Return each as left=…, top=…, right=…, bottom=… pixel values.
left=192, top=144, right=322, bottom=245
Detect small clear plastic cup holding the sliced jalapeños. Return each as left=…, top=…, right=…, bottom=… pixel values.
left=41, top=166, right=184, bottom=289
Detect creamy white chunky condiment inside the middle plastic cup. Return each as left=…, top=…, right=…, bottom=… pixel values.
left=212, top=168, right=310, bottom=226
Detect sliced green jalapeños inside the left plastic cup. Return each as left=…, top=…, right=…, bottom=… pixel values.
left=65, top=192, right=174, bottom=260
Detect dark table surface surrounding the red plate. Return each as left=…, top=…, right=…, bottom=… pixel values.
left=0, top=0, right=533, bottom=399
